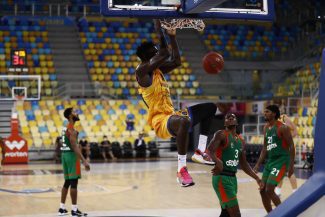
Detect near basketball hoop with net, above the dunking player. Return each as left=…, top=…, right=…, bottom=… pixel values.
left=160, top=18, right=205, bottom=31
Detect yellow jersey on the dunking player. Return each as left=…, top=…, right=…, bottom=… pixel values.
left=139, top=69, right=174, bottom=127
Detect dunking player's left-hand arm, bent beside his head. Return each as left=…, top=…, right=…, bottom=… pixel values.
left=135, top=20, right=170, bottom=87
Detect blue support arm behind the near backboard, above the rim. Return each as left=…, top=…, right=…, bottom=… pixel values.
left=182, top=0, right=227, bottom=14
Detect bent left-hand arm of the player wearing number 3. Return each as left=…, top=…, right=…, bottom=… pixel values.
left=208, top=130, right=226, bottom=175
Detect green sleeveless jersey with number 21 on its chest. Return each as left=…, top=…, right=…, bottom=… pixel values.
left=264, top=121, right=289, bottom=159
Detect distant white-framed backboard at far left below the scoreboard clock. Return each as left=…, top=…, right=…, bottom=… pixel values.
left=0, top=75, right=41, bottom=101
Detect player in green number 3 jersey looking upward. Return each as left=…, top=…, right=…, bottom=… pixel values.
left=208, top=113, right=263, bottom=217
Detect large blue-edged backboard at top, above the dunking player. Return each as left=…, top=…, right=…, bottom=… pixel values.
left=101, top=0, right=274, bottom=21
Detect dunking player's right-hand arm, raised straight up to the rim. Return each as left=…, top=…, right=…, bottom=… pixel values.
left=159, top=30, right=182, bottom=74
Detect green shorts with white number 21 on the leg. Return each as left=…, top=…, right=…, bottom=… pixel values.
left=262, top=156, right=290, bottom=186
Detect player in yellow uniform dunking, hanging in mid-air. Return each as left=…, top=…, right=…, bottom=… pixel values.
left=135, top=20, right=217, bottom=187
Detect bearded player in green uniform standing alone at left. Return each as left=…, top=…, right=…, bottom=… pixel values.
left=58, top=108, right=90, bottom=216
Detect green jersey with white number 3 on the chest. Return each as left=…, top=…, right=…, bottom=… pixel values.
left=216, top=130, right=244, bottom=173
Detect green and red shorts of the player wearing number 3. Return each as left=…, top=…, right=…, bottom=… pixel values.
left=212, top=175, right=238, bottom=209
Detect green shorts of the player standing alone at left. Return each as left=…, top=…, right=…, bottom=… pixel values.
left=61, top=152, right=81, bottom=180
